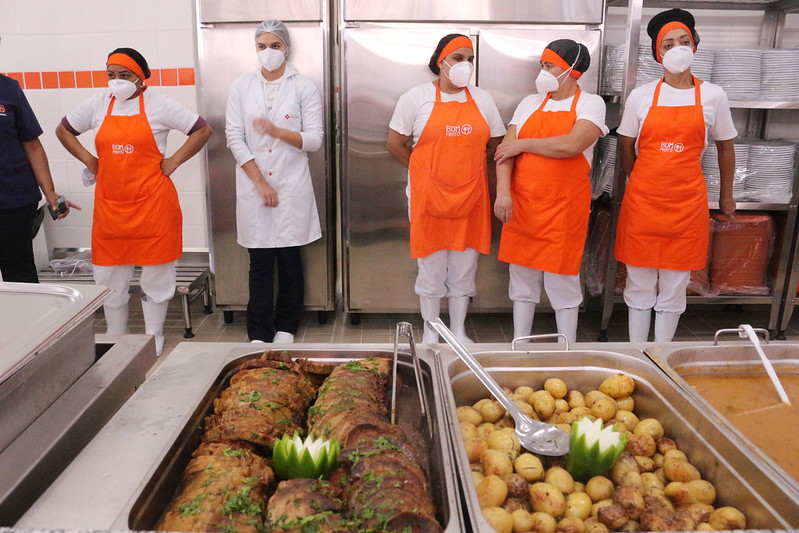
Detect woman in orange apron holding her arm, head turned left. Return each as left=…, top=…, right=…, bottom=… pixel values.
left=494, top=39, right=608, bottom=342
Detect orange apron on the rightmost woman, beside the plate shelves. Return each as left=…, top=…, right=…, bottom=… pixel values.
left=614, top=78, right=710, bottom=270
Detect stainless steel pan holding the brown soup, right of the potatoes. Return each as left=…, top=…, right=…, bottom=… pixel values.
left=644, top=342, right=799, bottom=494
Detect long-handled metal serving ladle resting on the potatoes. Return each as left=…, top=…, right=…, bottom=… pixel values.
left=428, top=318, right=569, bottom=455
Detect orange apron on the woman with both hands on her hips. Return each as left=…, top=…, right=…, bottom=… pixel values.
left=92, top=93, right=183, bottom=266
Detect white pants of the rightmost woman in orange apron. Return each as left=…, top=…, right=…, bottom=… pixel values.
left=624, top=265, right=691, bottom=313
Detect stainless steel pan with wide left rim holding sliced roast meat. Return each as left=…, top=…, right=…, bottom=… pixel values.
left=16, top=343, right=464, bottom=533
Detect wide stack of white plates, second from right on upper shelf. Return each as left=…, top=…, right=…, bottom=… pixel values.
left=710, top=49, right=763, bottom=100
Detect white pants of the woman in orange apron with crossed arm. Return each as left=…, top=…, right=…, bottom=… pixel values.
left=508, top=264, right=583, bottom=311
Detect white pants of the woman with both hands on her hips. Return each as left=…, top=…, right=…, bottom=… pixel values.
left=92, top=261, right=177, bottom=307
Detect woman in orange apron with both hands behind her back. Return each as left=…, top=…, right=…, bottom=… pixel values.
left=386, top=34, right=505, bottom=343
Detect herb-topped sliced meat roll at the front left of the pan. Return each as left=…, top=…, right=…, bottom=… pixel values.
left=155, top=442, right=274, bottom=533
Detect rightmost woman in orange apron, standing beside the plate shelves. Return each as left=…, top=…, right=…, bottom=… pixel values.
left=614, top=9, right=737, bottom=342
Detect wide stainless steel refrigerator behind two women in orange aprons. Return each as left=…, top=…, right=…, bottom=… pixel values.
left=338, top=0, right=605, bottom=316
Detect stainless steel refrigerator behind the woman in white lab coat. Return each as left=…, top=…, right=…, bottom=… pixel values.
left=202, top=0, right=336, bottom=322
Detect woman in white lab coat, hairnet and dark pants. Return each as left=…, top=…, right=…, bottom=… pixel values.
left=225, top=20, right=323, bottom=343
